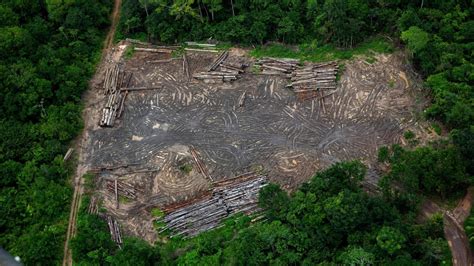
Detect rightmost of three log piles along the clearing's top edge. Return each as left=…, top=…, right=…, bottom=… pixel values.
left=287, top=62, right=338, bottom=98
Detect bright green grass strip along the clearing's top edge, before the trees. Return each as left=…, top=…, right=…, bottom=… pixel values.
left=250, top=37, right=394, bottom=62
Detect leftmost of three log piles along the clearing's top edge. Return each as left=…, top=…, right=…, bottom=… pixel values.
left=193, top=51, right=246, bottom=83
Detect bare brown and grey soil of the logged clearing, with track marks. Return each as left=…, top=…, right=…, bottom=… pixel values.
left=79, top=43, right=433, bottom=243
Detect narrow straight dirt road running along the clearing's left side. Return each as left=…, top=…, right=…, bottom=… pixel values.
left=62, top=0, right=122, bottom=266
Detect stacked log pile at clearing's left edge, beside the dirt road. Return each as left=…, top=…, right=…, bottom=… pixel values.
left=99, top=64, right=132, bottom=127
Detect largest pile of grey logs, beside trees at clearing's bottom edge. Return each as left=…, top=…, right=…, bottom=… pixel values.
left=159, top=176, right=267, bottom=237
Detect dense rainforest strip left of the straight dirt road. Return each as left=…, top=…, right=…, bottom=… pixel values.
left=0, top=0, right=113, bottom=265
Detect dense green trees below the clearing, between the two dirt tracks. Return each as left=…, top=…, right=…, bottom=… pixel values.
left=73, top=162, right=450, bottom=265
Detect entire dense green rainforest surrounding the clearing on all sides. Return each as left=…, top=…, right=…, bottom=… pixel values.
left=0, top=0, right=474, bottom=265
